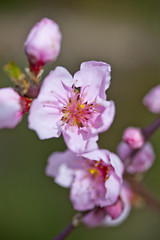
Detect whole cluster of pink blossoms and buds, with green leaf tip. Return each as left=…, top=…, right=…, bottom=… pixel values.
left=0, top=18, right=160, bottom=231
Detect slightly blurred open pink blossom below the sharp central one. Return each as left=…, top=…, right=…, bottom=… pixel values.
left=46, top=150, right=123, bottom=211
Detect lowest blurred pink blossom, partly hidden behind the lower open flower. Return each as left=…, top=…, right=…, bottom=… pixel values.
left=83, top=185, right=133, bottom=227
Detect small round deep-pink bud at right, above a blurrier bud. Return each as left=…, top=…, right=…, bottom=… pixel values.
left=123, top=127, right=144, bottom=149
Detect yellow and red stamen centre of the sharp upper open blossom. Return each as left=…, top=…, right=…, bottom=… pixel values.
left=61, top=88, right=97, bottom=128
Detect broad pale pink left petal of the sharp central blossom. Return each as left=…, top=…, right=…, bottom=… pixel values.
left=28, top=67, right=73, bottom=139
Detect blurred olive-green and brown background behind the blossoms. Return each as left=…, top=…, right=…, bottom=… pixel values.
left=0, top=0, right=160, bottom=240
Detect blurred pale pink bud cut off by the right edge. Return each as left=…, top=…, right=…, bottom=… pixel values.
left=143, top=85, right=160, bottom=113
